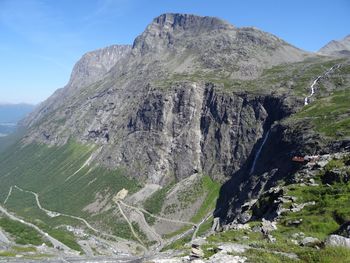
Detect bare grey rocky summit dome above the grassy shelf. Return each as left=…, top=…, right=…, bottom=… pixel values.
left=132, top=14, right=307, bottom=79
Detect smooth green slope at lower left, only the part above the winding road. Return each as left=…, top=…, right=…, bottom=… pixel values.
left=0, top=141, right=138, bottom=220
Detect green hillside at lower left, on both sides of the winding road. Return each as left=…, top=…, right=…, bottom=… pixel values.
left=0, top=141, right=140, bottom=241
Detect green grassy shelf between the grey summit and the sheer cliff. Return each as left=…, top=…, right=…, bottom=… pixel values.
left=153, top=57, right=349, bottom=97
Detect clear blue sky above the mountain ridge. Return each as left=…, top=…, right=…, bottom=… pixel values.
left=0, top=0, right=350, bottom=103
